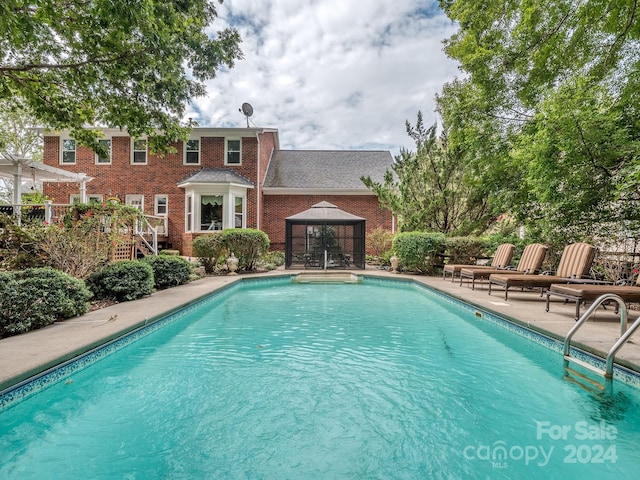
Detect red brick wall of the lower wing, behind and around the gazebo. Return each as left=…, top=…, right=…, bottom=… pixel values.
left=263, top=195, right=392, bottom=251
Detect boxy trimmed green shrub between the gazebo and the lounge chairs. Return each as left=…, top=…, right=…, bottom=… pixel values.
left=393, top=232, right=445, bottom=273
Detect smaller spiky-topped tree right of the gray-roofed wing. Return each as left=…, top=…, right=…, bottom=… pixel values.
left=362, top=112, right=491, bottom=234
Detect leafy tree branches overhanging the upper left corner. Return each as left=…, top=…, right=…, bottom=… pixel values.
left=0, top=0, right=242, bottom=151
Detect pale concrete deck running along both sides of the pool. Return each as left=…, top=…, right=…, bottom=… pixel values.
left=0, top=268, right=640, bottom=391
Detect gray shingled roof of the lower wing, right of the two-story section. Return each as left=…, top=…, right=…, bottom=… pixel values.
left=264, top=150, right=393, bottom=190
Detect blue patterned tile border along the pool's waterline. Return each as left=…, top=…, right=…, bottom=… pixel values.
left=0, top=276, right=640, bottom=411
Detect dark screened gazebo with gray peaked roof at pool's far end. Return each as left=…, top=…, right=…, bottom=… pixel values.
left=285, top=202, right=365, bottom=270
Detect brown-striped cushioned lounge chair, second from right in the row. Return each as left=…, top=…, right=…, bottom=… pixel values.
left=489, top=242, right=596, bottom=300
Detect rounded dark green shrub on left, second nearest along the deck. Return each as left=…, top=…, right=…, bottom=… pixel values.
left=87, top=260, right=154, bottom=301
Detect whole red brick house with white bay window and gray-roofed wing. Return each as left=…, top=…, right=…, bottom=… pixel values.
left=43, top=128, right=393, bottom=255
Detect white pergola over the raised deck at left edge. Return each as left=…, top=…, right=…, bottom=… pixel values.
left=0, top=153, right=93, bottom=205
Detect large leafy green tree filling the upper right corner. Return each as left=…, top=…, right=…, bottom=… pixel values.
left=439, top=0, right=640, bottom=240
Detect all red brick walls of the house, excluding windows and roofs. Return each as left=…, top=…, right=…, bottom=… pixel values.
left=44, top=132, right=392, bottom=256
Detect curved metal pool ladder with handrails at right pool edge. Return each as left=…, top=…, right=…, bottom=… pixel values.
left=564, top=293, right=640, bottom=380
